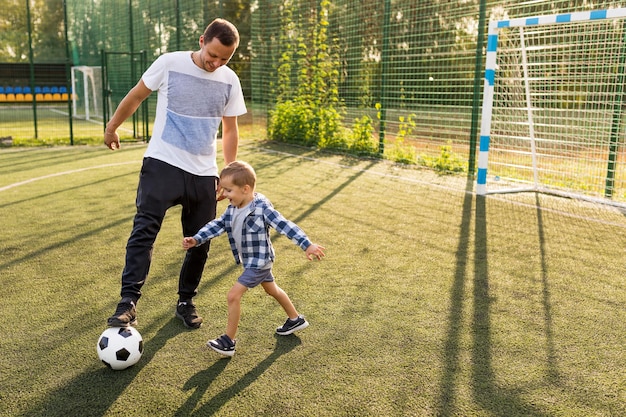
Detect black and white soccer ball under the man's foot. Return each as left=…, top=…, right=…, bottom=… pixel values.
left=96, top=326, right=143, bottom=371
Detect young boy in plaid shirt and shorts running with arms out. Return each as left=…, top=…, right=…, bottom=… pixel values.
left=183, top=161, right=325, bottom=356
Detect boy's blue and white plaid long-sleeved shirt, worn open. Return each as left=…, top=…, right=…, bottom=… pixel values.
left=193, top=193, right=311, bottom=269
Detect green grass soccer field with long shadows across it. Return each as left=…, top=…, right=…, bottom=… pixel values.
left=0, top=140, right=626, bottom=417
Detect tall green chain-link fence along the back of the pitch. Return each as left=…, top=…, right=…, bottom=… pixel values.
left=0, top=0, right=623, bottom=202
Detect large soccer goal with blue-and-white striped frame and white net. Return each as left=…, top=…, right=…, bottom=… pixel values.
left=476, top=8, right=626, bottom=205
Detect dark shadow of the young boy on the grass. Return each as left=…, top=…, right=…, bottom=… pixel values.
left=175, top=335, right=302, bottom=417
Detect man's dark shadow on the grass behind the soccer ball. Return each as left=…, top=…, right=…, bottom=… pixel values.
left=20, top=317, right=186, bottom=417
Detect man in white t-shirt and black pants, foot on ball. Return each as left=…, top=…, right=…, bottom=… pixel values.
left=104, top=19, right=246, bottom=329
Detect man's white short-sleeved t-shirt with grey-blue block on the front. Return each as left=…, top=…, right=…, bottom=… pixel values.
left=142, top=51, right=246, bottom=176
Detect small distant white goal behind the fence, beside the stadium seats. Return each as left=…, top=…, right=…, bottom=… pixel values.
left=71, top=65, right=104, bottom=121
